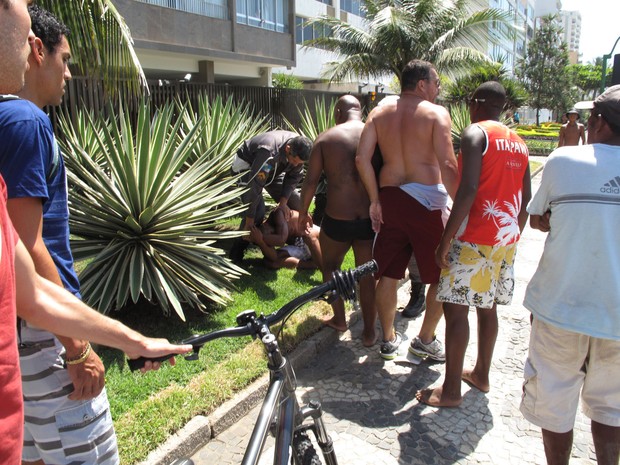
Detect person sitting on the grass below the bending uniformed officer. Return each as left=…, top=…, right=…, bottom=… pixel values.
left=250, top=208, right=321, bottom=270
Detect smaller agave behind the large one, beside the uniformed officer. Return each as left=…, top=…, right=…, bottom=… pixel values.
left=177, top=94, right=268, bottom=168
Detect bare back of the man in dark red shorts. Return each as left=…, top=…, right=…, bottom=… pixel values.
left=373, top=95, right=441, bottom=187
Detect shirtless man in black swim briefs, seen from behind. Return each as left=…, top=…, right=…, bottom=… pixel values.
left=299, top=95, right=377, bottom=347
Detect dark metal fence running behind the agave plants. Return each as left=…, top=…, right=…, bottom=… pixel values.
left=49, top=77, right=372, bottom=133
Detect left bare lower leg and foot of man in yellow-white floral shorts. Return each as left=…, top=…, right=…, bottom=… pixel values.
left=416, top=302, right=469, bottom=407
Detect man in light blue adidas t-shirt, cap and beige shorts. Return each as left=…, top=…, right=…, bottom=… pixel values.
left=521, top=85, right=620, bottom=465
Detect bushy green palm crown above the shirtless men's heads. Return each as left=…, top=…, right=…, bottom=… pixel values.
left=304, top=0, right=512, bottom=81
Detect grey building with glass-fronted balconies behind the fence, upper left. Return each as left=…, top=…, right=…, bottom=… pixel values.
left=114, top=0, right=296, bottom=86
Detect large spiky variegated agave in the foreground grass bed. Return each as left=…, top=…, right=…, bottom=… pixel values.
left=61, top=102, right=248, bottom=319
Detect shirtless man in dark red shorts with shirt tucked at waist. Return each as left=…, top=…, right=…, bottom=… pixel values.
left=356, top=60, right=458, bottom=361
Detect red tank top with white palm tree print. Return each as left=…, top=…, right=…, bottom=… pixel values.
left=456, top=121, right=528, bottom=245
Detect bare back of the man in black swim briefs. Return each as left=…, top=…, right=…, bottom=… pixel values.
left=316, top=121, right=370, bottom=220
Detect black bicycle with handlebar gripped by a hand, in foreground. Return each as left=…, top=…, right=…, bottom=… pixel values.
left=129, top=260, right=377, bottom=465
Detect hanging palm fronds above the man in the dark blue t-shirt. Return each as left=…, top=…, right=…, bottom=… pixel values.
left=37, top=0, right=148, bottom=96
